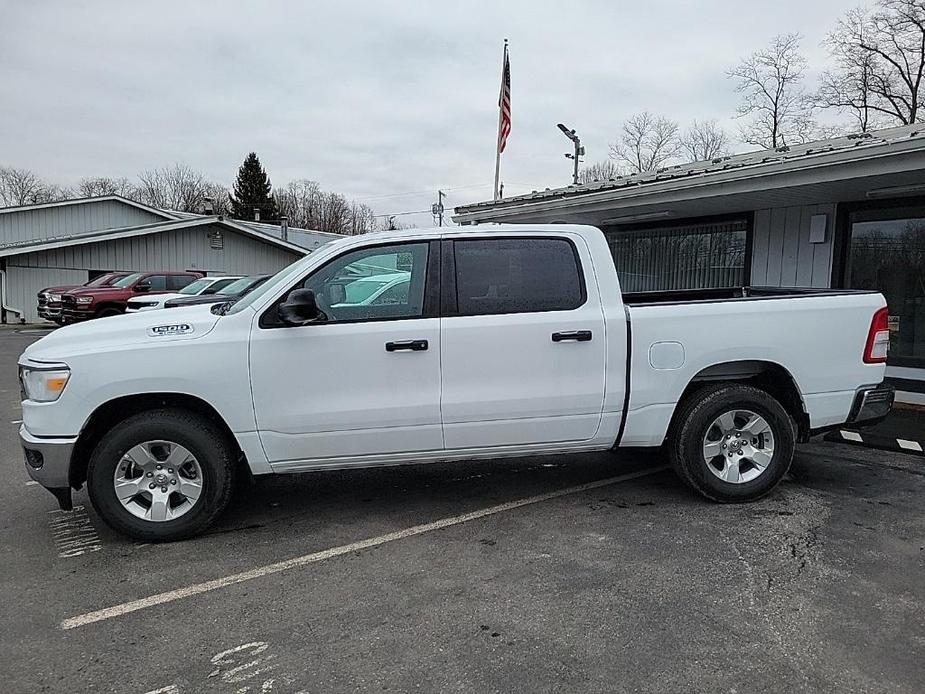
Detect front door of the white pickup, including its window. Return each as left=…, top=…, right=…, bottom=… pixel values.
left=249, top=241, right=443, bottom=470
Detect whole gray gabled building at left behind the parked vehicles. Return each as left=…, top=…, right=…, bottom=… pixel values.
left=0, top=195, right=340, bottom=322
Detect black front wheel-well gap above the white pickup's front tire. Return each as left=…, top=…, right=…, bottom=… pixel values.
left=69, top=393, right=244, bottom=489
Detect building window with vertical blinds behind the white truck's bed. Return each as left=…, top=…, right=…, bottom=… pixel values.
left=603, top=219, right=748, bottom=292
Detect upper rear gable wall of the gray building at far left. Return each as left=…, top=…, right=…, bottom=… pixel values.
left=0, top=200, right=166, bottom=244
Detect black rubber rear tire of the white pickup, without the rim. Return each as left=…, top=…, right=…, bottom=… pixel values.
left=668, top=383, right=796, bottom=503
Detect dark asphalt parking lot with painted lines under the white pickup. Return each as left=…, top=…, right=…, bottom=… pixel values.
left=0, top=331, right=925, bottom=694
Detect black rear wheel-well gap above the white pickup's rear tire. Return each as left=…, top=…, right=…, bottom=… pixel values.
left=669, top=359, right=809, bottom=441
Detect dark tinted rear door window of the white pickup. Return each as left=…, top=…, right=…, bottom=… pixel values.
left=453, top=238, right=585, bottom=316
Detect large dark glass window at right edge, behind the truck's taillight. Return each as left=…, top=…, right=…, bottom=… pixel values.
left=845, top=206, right=925, bottom=368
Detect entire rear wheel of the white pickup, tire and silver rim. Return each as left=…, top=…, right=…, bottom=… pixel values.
left=668, top=383, right=795, bottom=503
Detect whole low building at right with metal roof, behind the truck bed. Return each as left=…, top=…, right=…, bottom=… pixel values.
left=453, top=124, right=925, bottom=404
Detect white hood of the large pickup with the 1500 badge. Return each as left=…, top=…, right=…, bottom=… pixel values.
left=20, top=306, right=221, bottom=363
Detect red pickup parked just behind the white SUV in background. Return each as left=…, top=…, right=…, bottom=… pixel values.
left=61, top=272, right=203, bottom=323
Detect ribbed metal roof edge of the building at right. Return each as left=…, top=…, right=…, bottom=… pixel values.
left=455, top=123, right=925, bottom=215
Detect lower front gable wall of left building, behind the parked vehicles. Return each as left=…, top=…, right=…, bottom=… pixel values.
left=6, top=225, right=302, bottom=322
